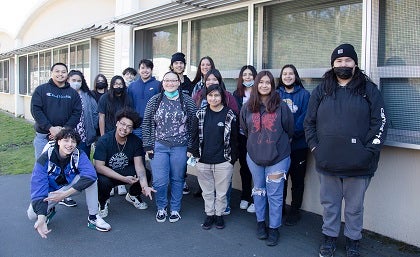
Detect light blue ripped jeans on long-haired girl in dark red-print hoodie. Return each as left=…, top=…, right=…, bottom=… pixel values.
left=246, top=154, right=290, bottom=228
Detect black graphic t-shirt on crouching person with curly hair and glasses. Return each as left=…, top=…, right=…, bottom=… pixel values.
left=93, top=129, right=144, bottom=172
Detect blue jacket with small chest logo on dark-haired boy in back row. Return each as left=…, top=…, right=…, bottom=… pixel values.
left=128, top=77, right=161, bottom=118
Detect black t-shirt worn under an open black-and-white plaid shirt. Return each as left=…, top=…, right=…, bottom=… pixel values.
left=200, top=107, right=229, bottom=164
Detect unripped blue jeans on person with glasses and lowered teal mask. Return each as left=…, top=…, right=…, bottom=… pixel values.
left=150, top=142, right=187, bottom=212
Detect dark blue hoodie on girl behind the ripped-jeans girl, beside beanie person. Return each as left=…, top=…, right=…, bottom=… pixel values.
left=277, top=85, right=311, bottom=151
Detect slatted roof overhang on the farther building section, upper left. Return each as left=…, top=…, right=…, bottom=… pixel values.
left=0, top=24, right=114, bottom=59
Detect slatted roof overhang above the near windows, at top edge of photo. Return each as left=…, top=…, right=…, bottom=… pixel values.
left=112, top=0, right=250, bottom=26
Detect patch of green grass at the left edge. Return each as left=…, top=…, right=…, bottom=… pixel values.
left=0, top=111, right=35, bottom=175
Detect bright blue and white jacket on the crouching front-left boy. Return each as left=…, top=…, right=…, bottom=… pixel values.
left=31, top=145, right=97, bottom=215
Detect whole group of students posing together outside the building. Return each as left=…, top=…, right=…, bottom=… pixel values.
left=28, top=44, right=387, bottom=256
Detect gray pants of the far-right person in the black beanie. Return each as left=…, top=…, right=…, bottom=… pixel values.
left=319, top=173, right=371, bottom=240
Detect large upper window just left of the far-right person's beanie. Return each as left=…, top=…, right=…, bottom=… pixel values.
left=262, top=0, right=363, bottom=69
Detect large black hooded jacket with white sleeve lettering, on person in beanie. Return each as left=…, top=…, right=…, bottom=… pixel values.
left=304, top=82, right=387, bottom=177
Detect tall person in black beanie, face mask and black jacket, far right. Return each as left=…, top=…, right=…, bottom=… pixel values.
left=304, top=44, right=388, bottom=257
